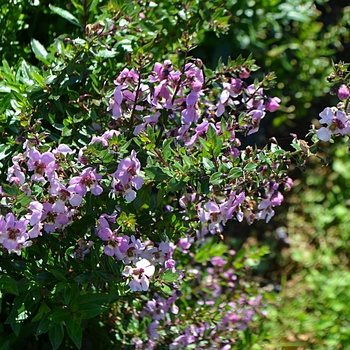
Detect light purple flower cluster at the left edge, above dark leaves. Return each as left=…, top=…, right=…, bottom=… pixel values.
left=0, top=137, right=143, bottom=254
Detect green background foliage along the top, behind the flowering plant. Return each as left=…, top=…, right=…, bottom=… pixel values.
left=0, top=0, right=349, bottom=132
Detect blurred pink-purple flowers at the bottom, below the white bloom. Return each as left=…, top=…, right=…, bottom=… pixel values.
left=130, top=251, right=262, bottom=349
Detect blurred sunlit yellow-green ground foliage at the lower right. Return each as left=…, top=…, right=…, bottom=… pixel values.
left=265, top=138, right=349, bottom=349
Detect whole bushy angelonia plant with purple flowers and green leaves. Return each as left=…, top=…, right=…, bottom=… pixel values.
left=0, top=6, right=344, bottom=350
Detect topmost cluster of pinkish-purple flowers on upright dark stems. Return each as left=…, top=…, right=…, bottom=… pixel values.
left=107, top=60, right=280, bottom=145
